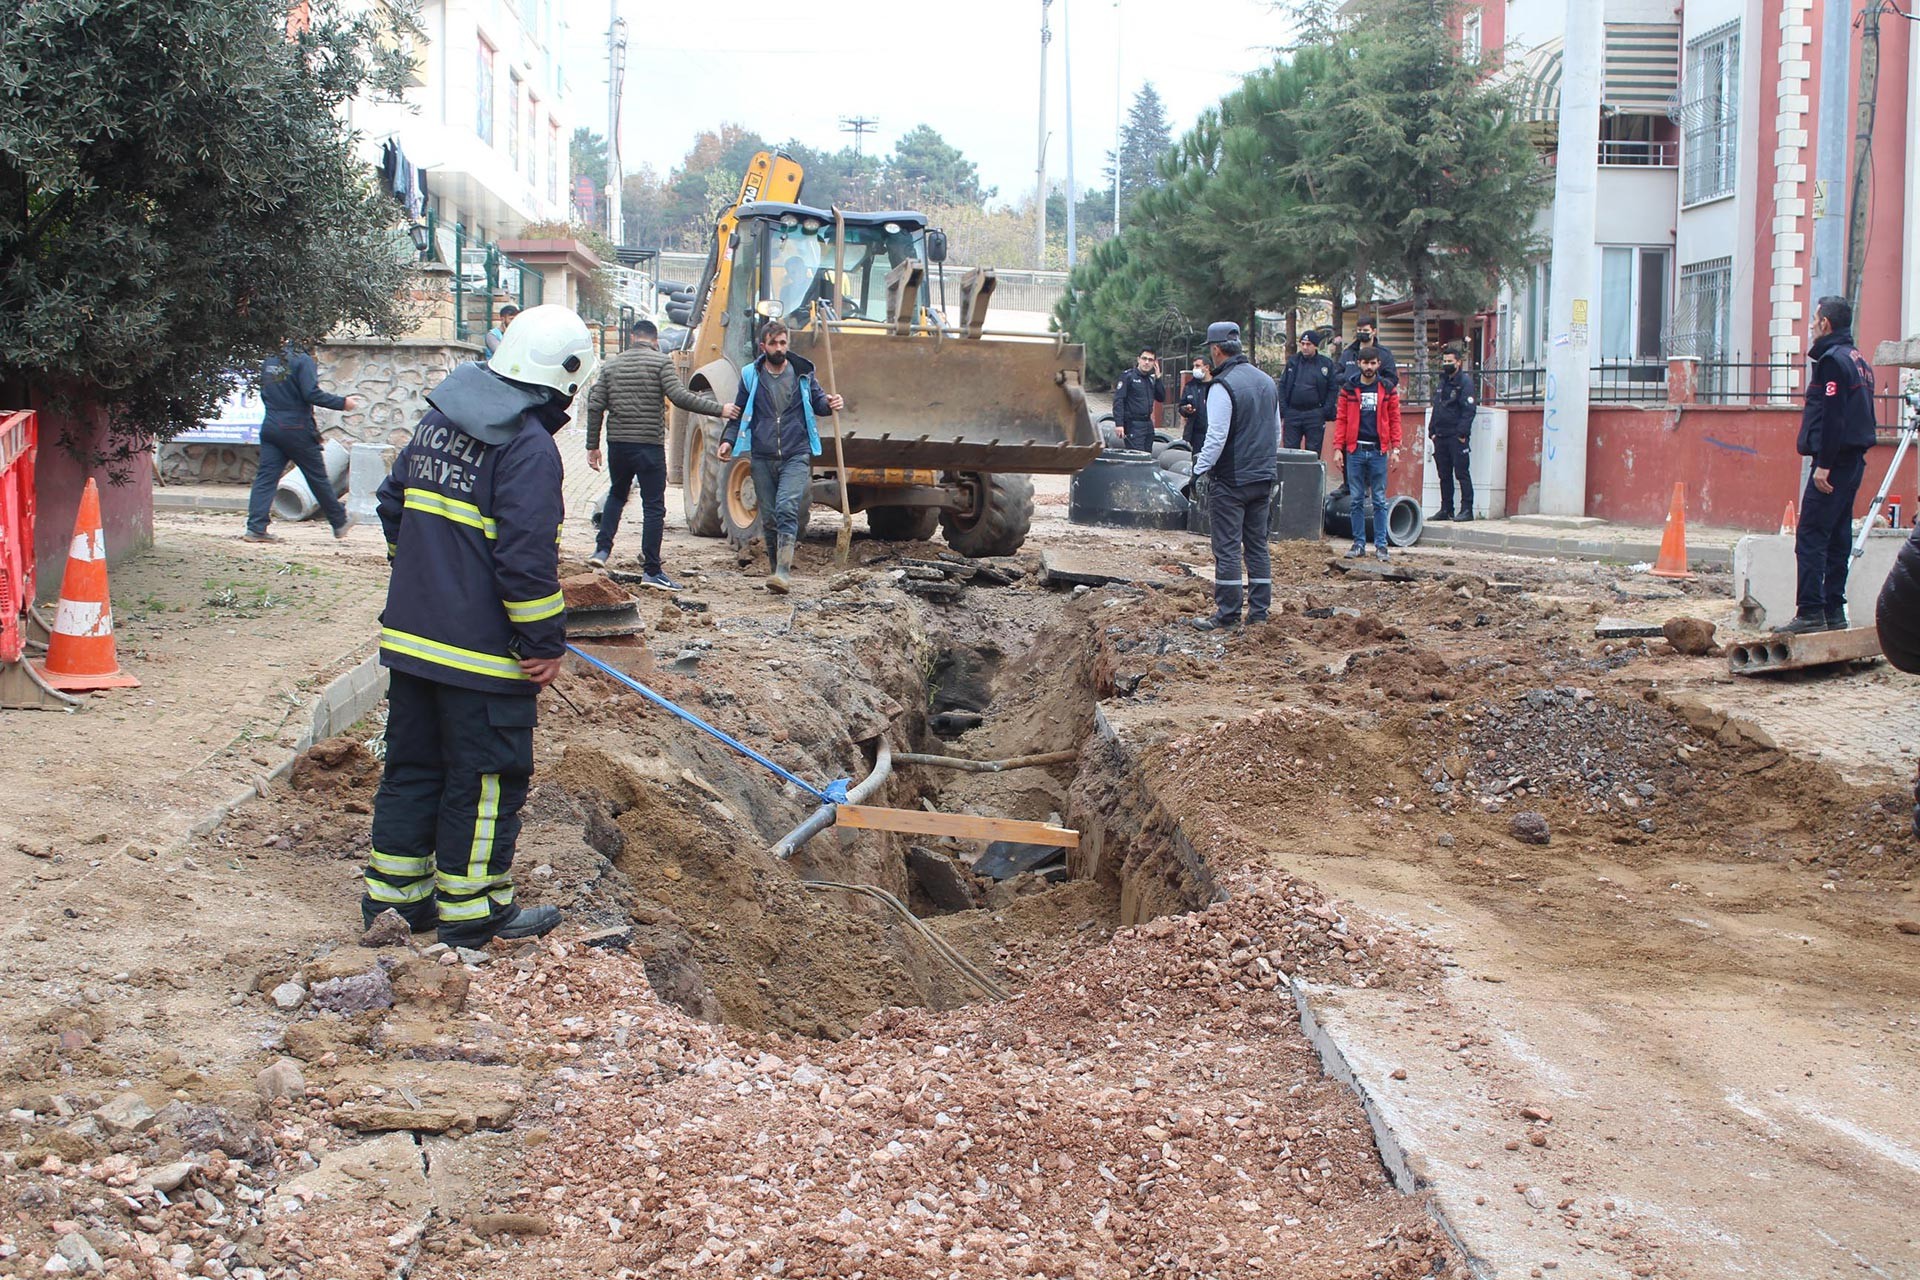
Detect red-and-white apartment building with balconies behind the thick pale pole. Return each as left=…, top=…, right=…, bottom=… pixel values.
left=1461, top=0, right=1920, bottom=399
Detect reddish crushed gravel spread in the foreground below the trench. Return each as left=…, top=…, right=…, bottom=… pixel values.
left=393, top=904, right=1465, bottom=1278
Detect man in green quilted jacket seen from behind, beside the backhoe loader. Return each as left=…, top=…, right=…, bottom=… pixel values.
left=588, top=320, right=720, bottom=591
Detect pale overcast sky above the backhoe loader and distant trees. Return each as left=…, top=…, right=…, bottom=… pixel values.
left=566, top=0, right=1288, bottom=200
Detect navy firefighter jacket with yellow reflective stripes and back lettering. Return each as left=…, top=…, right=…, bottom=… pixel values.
left=378, top=363, right=566, bottom=697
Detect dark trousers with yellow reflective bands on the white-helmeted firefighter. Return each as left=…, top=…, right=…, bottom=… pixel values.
left=361, top=672, right=534, bottom=940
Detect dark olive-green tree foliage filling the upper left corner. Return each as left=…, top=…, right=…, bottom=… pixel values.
left=0, top=0, right=413, bottom=450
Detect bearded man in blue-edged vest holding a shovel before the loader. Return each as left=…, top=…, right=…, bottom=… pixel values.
left=720, top=320, right=847, bottom=595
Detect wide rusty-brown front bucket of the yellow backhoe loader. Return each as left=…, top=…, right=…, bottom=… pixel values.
left=793, top=324, right=1100, bottom=476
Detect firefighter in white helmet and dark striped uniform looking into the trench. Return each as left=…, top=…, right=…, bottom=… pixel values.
left=361, top=307, right=593, bottom=946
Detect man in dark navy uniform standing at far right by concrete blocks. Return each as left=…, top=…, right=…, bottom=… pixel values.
left=1778, top=297, right=1874, bottom=633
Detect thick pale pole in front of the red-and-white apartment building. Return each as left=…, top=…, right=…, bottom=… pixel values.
left=1540, top=0, right=1605, bottom=516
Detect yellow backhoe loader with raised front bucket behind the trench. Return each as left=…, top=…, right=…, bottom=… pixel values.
left=668, top=152, right=1100, bottom=557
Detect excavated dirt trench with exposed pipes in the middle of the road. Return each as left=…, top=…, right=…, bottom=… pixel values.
left=549, top=593, right=1212, bottom=1038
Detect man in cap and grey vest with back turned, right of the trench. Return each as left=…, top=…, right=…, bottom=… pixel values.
left=1194, top=320, right=1281, bottom=631
